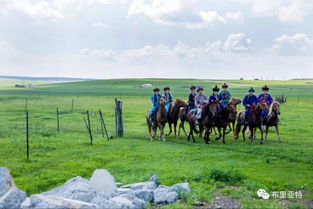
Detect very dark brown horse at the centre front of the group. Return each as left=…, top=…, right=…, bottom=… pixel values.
left=209, top=102, right=229, bottom=144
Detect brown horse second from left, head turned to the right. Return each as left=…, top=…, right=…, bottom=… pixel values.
left=166, top=99, right=187, bottom=138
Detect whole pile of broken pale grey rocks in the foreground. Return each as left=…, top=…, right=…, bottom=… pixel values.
left=0, top=167, right=190, bottom=209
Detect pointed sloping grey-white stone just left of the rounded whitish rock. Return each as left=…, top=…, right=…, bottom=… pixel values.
left=43, top=176, right=96, bottom=202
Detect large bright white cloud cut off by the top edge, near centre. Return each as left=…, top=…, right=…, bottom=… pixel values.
left=128, top=0, right=243, bottom=29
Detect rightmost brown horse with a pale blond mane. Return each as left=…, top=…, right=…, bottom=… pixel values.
left=264, top=101, right=281, bottom=142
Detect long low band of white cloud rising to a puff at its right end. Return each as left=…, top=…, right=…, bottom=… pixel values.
left=80, top=33, right=252, bottom=62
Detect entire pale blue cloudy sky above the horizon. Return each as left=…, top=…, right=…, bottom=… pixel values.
left=0, top=0, right=313, bottom=79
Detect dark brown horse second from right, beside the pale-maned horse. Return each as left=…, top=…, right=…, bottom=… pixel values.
left=235, top=100, right=267, bottom=144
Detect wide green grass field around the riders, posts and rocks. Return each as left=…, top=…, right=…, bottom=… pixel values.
left=0, top=79, right=313, bottom=208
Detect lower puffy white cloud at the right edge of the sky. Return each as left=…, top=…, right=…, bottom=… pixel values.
left=272, top=33, right=313, bottom=56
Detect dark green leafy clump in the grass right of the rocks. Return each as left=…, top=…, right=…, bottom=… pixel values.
left=210, top=169, right=245, bottom=184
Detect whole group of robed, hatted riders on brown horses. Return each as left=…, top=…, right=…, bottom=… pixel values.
left=147, top=83, right=280, bottom=143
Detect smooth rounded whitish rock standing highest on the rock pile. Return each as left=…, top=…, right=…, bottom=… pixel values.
left=90, top=169, right=117, bottom=195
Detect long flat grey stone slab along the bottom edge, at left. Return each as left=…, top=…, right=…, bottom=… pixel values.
left=29, top=194, right=98, bottom=209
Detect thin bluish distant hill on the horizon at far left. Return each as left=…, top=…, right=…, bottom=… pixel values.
left=0, top=75, right=96, bottom=82
